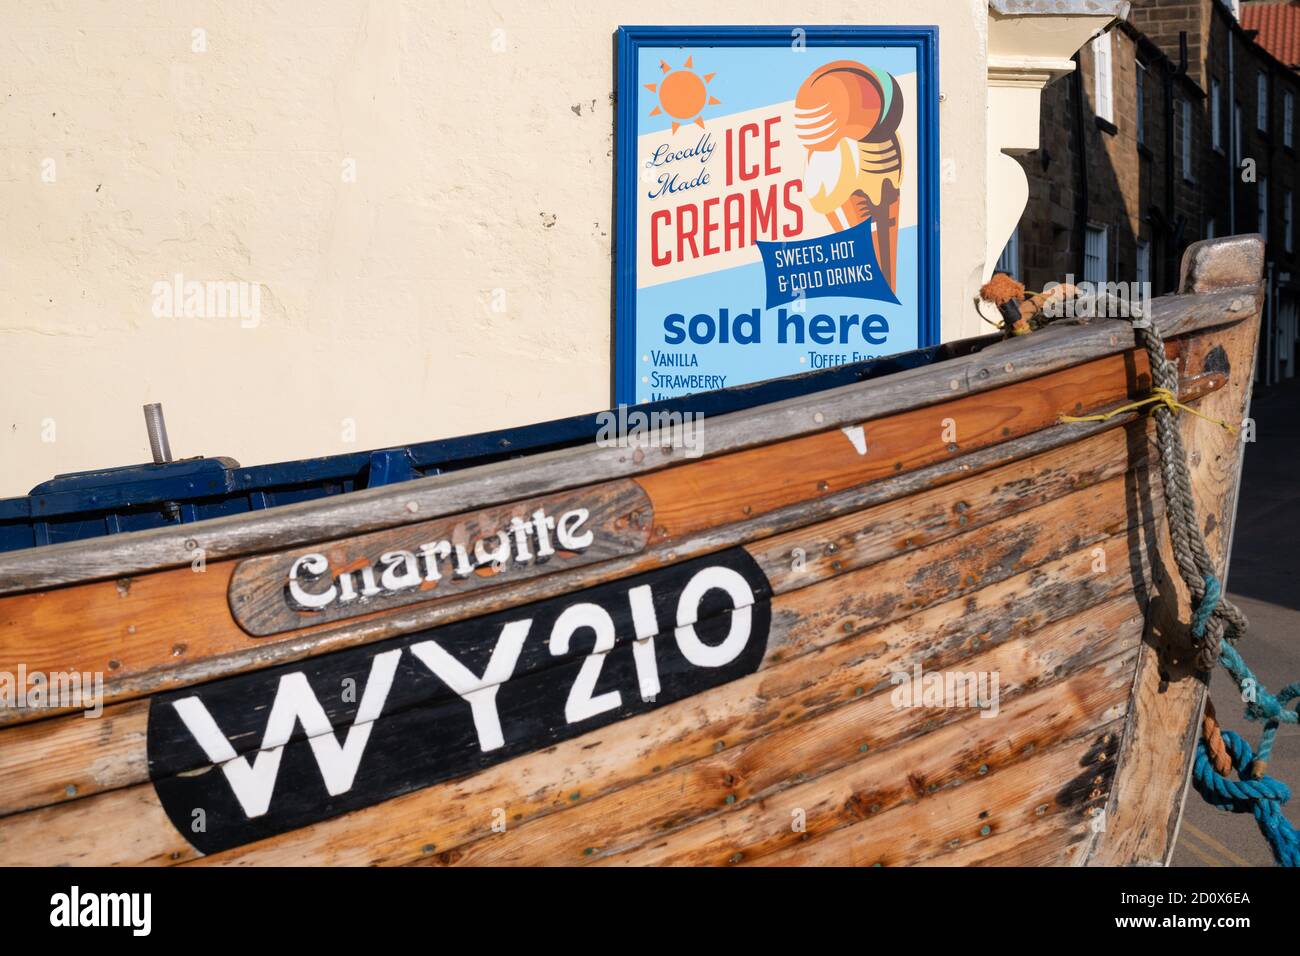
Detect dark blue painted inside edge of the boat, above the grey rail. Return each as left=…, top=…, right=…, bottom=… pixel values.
left=0, top=336, right=997, bottom=551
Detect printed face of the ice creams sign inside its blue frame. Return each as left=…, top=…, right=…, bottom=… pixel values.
left=634, top=46, right=920, bottom=402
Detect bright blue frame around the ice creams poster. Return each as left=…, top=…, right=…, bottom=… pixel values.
left=614, top=26, right=940, bottom=405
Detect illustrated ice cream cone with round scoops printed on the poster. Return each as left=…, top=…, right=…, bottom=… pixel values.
left=794, top=60, right=904, bottom=289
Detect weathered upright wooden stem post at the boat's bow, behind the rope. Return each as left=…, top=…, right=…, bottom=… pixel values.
left=1088, top=297, right=1258, bottom=865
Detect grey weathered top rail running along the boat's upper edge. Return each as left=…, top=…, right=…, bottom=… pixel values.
left=0, top=291, right=1256, bottom=594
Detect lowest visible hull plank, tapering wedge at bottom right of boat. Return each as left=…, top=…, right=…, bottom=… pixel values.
left=759, top=718, right=1123, bottom=866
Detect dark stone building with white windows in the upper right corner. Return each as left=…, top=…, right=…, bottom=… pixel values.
left=1000, top=0, right=1300, bottom=384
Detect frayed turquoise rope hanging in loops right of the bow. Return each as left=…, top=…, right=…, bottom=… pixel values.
left=1192, top=575, right=1300, bottom=866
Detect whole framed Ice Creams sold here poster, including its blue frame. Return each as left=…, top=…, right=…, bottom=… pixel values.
left=615, top=27, right=939, bottom=405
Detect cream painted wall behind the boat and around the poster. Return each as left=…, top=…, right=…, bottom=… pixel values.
left=0, top=0, right=987, bottom=497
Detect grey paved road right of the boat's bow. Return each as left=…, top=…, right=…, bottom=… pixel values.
left=1173, top=380, right=1300, bottom=866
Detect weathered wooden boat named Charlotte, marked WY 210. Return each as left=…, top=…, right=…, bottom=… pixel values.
left=0, top=237, right=1264, bottom=866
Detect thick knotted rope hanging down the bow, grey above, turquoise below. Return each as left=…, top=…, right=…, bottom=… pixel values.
left=1061, top=297, right=1300, bottom=866
